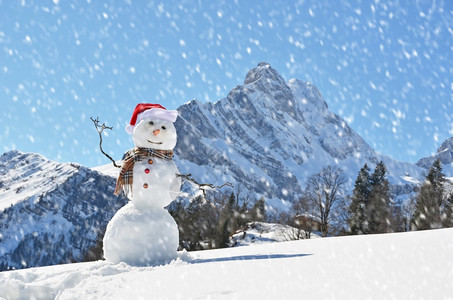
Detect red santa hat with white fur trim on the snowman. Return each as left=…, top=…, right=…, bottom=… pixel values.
left=126, top=103, right=178, bottom=134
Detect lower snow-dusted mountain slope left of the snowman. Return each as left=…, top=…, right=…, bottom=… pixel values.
left=0, top=151, right=126, bottom=270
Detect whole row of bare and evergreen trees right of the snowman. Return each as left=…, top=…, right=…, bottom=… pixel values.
left=170, top=160, right=453, bottom=245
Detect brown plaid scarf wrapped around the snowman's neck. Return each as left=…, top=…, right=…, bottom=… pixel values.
left=113, top=147, right=173, bottom=196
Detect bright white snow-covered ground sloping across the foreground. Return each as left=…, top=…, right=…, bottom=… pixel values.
left=0, top=229, right=453, bottom=299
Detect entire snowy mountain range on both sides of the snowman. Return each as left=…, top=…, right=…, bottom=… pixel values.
left=0, top=63, right=453, bottom=270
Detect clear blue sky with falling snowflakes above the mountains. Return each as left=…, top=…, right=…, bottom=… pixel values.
left=0, top=0, right=453, bottom=166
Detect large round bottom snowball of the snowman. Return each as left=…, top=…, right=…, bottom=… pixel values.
left=104, top=202, right=179, bottom=266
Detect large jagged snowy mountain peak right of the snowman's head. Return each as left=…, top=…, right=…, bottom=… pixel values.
left=176, top=63, right=422, bottom=206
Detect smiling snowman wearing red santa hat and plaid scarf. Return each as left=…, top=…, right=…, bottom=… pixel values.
left=104, top=103, right=181, bottom=266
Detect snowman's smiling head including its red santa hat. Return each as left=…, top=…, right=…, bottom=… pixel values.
left=126, top=103, right=178, bottom=150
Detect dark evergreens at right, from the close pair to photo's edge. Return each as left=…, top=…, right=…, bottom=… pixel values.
left=348, top=160, right=453, bottom=234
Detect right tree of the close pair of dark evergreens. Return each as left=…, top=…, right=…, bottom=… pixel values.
left=365, top=161, right=390, bottom=233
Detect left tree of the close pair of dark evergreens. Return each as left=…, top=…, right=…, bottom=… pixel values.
left=349, top=164, right=371, bottom=234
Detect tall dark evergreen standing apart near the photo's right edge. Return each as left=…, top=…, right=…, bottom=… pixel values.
left=412, top=159, right=445, bottom=230
